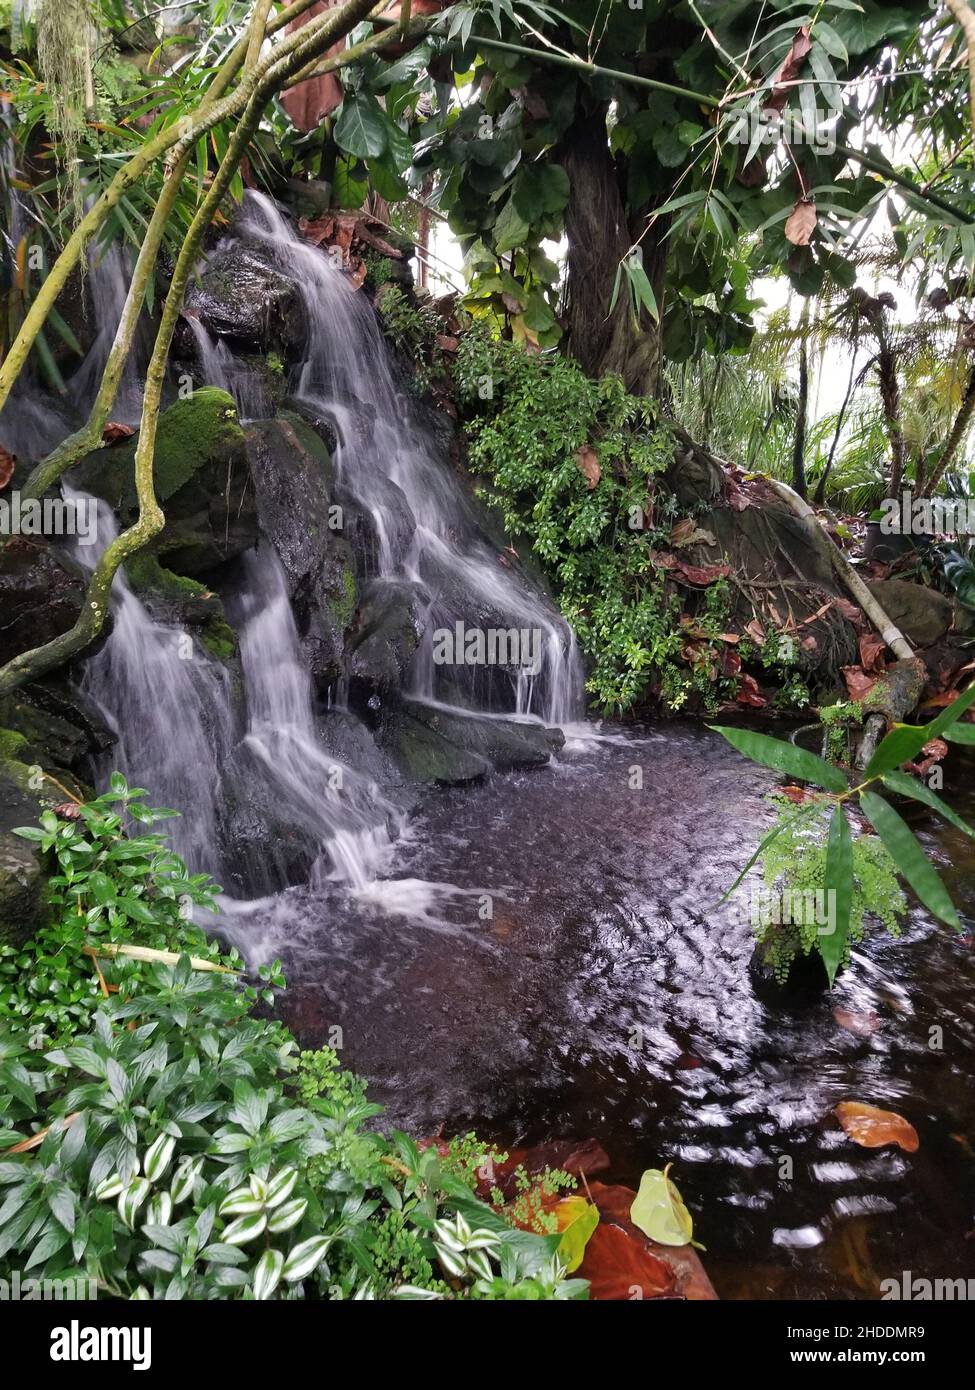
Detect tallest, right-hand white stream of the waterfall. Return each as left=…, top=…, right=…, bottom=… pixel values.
left=235, top=192, right=583, bottom=724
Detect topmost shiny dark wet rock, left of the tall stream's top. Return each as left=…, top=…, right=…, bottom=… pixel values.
left=186, top=242, right=306, bottom=356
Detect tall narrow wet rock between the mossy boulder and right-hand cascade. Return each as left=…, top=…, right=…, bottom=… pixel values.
left=245, top=411, right=357, bottom=687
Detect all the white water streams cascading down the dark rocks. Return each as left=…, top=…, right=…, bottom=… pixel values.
left=68, top=193, right=583, bottom=930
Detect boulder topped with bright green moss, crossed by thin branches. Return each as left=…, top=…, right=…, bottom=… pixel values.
left=68, top=386, right=257, bottom=575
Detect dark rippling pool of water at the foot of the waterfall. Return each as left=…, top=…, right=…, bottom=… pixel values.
left=239, top=726, right=975, bottom=1298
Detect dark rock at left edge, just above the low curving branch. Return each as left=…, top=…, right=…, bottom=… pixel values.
left=0, top=535, right=86, bottom=664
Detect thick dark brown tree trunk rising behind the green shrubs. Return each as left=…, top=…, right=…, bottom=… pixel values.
left=562, top=100, right=666, bottom=396
